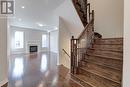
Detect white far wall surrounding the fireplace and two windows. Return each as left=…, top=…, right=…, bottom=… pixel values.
left=10, top=26, right=49, bottom=54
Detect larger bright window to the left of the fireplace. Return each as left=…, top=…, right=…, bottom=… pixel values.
left=14, top=31, right=24, bottom=49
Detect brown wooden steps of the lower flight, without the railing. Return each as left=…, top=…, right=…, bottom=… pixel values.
left=72, top=38, right=123, bottom=87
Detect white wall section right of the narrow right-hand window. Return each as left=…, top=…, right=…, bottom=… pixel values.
left=50, top=30, right=59, bottom=53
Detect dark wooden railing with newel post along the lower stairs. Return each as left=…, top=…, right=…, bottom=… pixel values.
left=71, top=7, right=94, bottom=74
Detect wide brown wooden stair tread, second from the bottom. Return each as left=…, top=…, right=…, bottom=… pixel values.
left=81, top=63, right=121, bottom=84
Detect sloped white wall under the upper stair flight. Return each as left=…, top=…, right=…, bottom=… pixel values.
left=54, top=0, right=84, bottom=37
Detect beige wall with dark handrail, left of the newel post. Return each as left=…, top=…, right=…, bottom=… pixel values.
left=59, top=18, right=71, bottom=68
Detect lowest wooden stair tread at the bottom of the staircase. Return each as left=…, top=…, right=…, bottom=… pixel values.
left=74, top=74, right=120, bottom=87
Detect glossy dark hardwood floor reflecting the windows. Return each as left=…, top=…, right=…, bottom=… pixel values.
left=8, top=52, right=81, bottom=87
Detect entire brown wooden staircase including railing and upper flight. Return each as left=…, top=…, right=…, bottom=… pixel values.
left=71, top=0, right=123, bottom=87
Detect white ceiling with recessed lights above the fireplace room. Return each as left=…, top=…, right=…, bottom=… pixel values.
left=9, top=0, right=65, bottom=31
